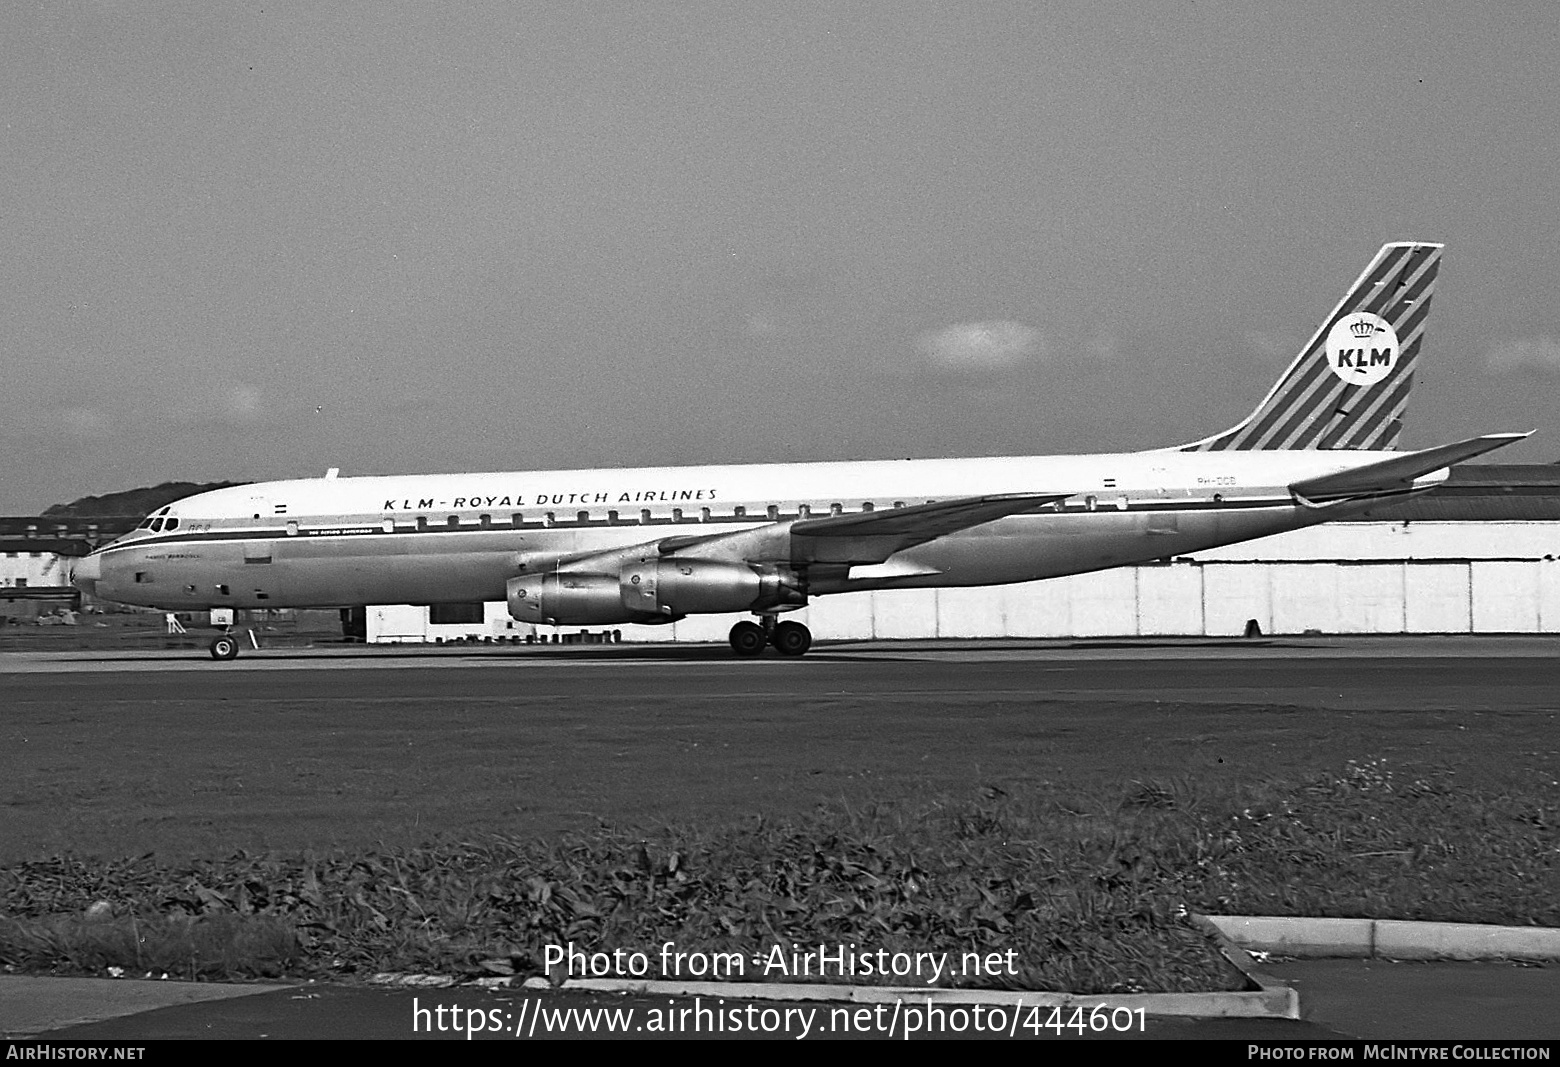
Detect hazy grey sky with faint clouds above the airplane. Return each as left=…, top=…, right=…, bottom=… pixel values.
left=0, top=0, right=1560, bottom=515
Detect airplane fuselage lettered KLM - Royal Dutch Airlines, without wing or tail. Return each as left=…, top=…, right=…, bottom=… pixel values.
left=76, top=451, right=1446, bottom=610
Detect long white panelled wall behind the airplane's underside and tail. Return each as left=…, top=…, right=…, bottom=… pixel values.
left=368, top=523, right=1560, bottom=641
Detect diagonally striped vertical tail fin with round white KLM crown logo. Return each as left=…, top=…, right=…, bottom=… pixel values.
left=1181, top=242, right=1443, bottom=452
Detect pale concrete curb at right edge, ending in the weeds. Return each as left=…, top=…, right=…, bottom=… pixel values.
left=1206, top=916, right=1560, bottom=961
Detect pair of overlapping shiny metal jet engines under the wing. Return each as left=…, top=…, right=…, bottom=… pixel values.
left=509, top=557, right=807, bottom=626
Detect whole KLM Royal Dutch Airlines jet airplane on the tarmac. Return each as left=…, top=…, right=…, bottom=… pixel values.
left=73, top=242, right=1529, bottom=660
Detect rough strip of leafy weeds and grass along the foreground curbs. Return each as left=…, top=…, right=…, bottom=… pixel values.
left=0, top=760, right=1560, bottom=992
